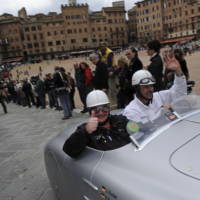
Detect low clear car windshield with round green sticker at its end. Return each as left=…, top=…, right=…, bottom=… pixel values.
left=127, top=95, right=200, bottom=150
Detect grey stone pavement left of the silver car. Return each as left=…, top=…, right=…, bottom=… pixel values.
left=0, top=104, right=86, bottom=200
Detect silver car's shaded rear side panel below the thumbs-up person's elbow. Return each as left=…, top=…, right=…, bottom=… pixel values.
left=44, top=123, right=103, bottom=199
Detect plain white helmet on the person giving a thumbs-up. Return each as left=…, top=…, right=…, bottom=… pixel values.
left=86, top=90, right=110, bottom=108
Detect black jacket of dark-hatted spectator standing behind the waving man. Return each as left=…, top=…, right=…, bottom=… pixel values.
left=148, top=54, right=163, bottom=91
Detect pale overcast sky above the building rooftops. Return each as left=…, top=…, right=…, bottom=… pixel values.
left=0, top=0, right=138, bottom=16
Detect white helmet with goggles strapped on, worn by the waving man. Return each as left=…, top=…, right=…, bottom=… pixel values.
left=132, top=69, right=156, bottom=86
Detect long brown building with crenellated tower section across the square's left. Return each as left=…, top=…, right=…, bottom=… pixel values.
left=0, top=0, right=128, bottom=60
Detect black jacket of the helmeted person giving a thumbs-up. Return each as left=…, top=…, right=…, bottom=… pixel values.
left=63, top=115, right=130, bottom=158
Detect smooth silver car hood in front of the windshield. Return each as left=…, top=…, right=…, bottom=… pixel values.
left=95, top=120, right=200, bottom=200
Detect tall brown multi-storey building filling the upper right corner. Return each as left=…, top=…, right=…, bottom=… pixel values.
left=128, top=0, right=200, bottom=43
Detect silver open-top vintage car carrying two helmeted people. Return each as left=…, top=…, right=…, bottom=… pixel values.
left=45, top=95, right=200, bottom=200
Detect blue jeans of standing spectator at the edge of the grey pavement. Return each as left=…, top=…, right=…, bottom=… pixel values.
left=58, top=90, right=72, bottom=117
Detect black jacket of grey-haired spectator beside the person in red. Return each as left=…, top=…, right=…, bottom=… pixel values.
left=93, top=61, right=108, bottom=90
